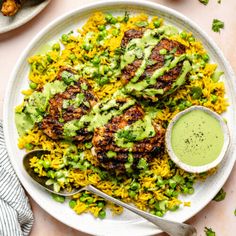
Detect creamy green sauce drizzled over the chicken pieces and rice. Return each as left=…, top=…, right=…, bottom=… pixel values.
left=15, top=26, right=191, bottom=140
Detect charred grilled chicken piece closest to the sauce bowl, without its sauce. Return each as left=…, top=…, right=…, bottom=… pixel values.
left=92, top=105, right=165, bottom=170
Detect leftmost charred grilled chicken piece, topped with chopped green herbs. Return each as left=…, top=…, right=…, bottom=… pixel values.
left=39, top=70, right=97, bottom=141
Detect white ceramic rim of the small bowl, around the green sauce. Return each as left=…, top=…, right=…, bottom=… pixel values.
left=165, top=106, right=230, bottom=173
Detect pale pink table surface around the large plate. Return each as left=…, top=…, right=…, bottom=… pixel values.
left=0, top=0, right=236, bottom=236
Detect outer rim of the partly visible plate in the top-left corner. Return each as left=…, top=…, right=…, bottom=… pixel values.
left=0, top=0, right=51, bottom=34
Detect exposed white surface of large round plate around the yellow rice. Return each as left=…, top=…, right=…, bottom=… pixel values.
left=4, top=1, right=236, bottom=236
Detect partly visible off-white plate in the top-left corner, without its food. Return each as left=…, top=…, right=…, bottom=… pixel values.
left=0, top=0, right=51, bottom=34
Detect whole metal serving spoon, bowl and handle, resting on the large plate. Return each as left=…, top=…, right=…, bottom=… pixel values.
left=23, top=149, right=197, bottom=236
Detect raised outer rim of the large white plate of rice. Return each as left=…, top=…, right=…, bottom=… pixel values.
left=3, top=0, right=236, bottom=233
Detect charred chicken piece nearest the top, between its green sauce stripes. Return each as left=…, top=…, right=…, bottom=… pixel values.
left=121, top=30, right=186, bottom=101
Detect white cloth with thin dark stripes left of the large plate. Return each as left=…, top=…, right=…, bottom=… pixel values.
left=0, top=121, right=34, bottom=236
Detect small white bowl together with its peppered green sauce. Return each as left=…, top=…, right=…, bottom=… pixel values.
left=166, top=106, right=229, bottom=173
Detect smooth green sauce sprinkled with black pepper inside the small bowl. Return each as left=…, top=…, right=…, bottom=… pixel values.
left=171, top=110, right=224, bottom=166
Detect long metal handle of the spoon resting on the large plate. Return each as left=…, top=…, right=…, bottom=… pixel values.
left=86, top=185, right=197, bottom=236
